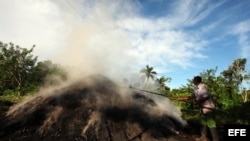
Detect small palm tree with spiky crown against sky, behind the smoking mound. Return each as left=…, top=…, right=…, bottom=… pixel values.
left=140, top=65, right=157, bottom=88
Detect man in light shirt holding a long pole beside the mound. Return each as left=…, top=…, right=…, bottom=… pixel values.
left=177, top=76, right=219, bottom=141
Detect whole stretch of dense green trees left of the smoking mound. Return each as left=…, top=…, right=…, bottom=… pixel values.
left=0, top=41, right=66, bottom=101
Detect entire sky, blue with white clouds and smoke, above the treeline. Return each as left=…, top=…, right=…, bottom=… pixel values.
left=0, top=0, right=250, bottom=88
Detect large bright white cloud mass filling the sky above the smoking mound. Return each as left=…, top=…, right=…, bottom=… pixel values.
left=0, top=0, right=219, bottom=85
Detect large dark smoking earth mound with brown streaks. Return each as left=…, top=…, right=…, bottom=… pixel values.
left=0, top=75, right=189, bottom=141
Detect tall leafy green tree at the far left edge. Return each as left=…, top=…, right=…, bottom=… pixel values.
left=0, top=41, right=37, bottom=95
